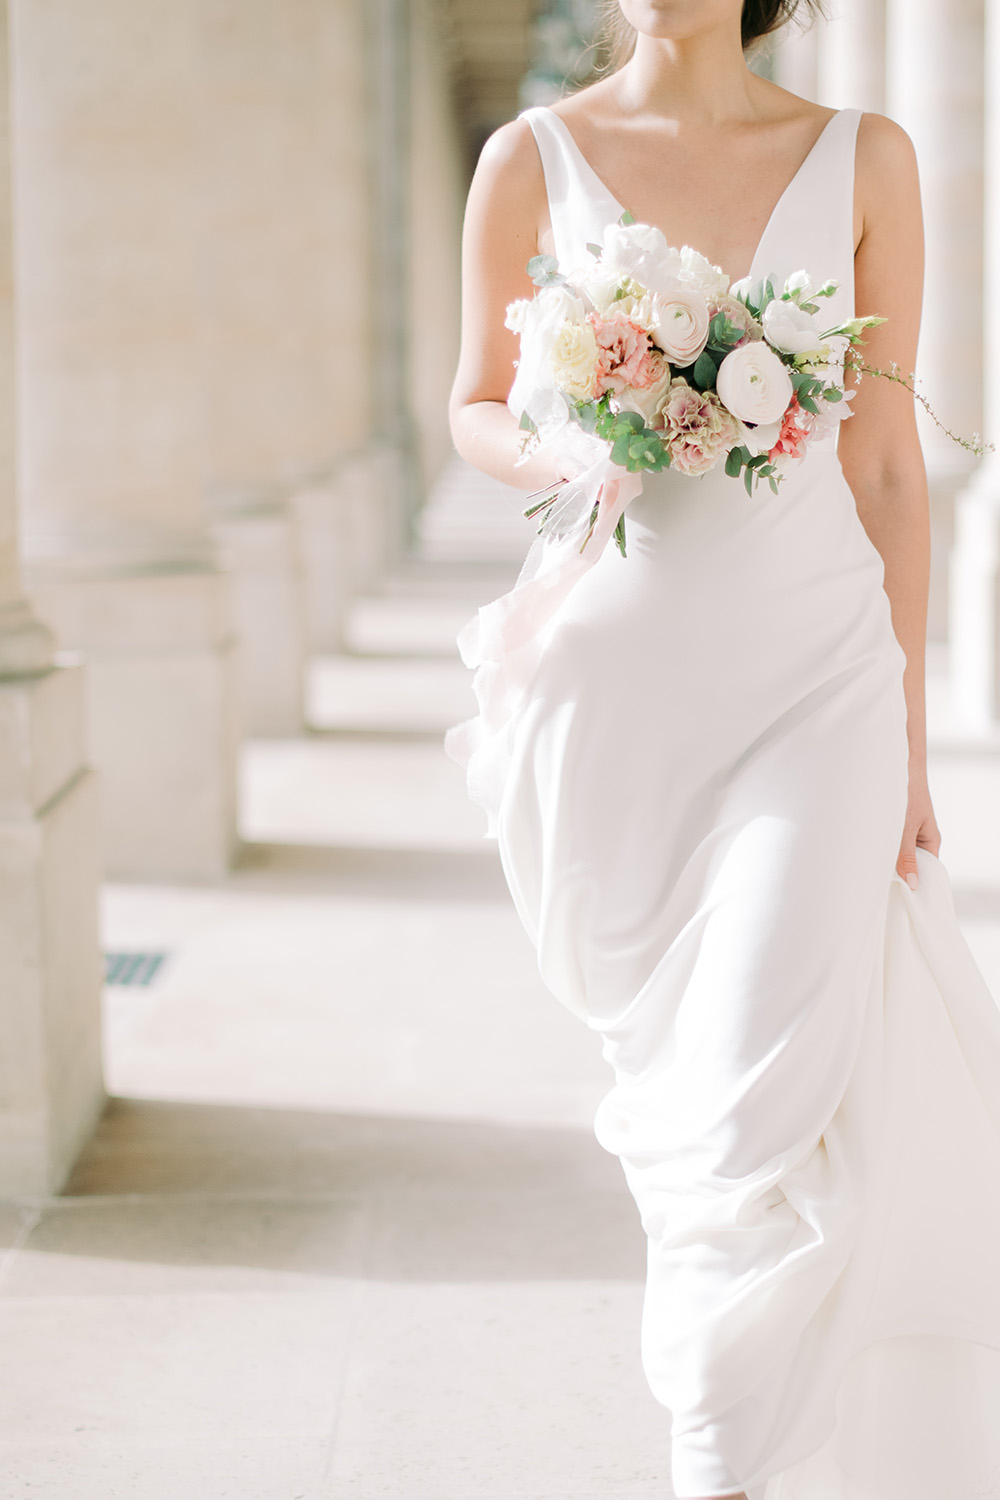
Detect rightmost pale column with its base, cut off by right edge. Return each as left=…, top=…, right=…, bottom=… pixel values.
left=949, top=0, right=1000, bottom=732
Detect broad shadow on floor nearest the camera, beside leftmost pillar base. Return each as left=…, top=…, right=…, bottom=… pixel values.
left=13, top=1098, right=645, bottom=1283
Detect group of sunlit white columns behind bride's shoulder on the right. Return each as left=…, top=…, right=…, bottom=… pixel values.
left=774, top=0, right=1000, bottom=660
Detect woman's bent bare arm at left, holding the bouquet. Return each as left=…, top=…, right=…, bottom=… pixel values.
left=450, top=120, right=590, bottom=491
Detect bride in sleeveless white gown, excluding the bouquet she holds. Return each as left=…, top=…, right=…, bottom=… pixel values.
left=450, top=0, right=1000, bottom=1500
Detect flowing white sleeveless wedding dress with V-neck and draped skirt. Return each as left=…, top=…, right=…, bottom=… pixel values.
left=450, top=108, right=1000, bottom=1500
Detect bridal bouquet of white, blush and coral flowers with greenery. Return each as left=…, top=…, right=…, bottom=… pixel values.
left=507, top=215, right=885, bottom=555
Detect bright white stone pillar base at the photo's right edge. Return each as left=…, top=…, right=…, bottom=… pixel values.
left=949, top=461, right=1000, bottom=734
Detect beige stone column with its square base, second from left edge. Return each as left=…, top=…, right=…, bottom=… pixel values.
left=13, top=0, right=238, bottom=878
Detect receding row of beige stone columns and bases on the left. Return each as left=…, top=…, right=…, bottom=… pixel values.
left=0, top=0, right=463, bottom=1194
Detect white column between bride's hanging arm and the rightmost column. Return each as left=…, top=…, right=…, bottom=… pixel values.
left=886, top=0, right=984, bottom=636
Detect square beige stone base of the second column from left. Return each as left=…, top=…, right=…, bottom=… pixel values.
left=31, top=569, right=237, bottom=881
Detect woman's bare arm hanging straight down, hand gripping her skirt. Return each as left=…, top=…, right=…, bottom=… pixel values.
left=840, top=114, right=942, bottom=885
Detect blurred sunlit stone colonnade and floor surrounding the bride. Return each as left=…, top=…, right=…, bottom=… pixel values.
left=0, top=0, right=1000, bottom=1500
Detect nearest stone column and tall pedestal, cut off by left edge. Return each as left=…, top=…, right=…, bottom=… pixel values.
left=0, top=3, right=103, bottom=1197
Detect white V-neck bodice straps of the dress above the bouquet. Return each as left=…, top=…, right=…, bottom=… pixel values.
left=522, top=105, right=861, bottom=328
